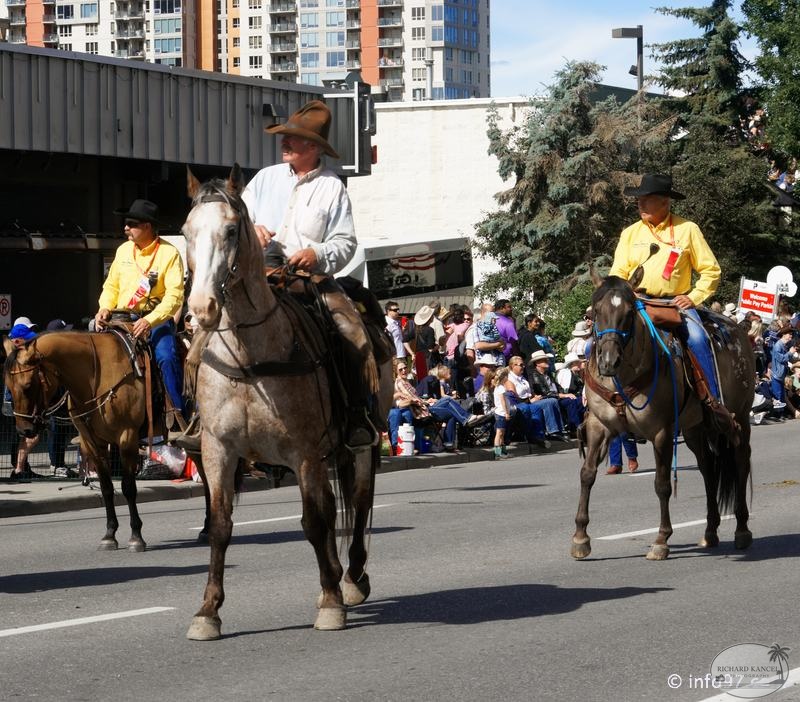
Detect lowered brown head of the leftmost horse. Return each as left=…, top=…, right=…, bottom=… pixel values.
left=4, top=340, right=57, bottom=438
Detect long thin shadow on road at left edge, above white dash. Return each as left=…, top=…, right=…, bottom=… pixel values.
left=0, top=565, right=212, bottom=594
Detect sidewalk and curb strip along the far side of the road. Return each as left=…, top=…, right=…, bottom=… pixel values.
left=0, top=441, right=577, bottom=519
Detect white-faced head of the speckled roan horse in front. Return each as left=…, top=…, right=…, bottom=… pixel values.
left=183, top=164, right=263, bottom=329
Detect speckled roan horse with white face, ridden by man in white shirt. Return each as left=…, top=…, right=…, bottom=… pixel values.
left=183, top=165, right=393, bottom=640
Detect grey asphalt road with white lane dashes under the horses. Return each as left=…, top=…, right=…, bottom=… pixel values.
left=0, top=422, right=800, bottom=702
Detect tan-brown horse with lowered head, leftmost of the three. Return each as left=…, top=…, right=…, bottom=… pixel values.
left=5, top=331, right=151, bottom=551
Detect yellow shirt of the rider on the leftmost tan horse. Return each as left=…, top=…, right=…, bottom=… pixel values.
left=100, top=237, right=183, bottom=327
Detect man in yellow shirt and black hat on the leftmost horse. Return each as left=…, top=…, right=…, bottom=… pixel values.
left=94, top=200, right=184, bottom=412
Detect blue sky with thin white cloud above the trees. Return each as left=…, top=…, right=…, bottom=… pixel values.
left=491, top=0, right=755, bottom=97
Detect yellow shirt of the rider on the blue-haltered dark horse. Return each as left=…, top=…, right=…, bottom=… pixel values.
left=608, top=214, right=720, bottom=305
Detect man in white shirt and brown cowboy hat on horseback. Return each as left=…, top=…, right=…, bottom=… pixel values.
left=242, top=100, right=380, bottom=449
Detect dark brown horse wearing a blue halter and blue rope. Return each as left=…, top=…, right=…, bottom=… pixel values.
left=572, top=274, right=755, bottom=560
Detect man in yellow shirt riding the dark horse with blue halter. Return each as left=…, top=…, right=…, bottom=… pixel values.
left=608, top=173, right=720, bottom=400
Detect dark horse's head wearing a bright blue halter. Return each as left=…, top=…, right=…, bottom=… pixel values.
left=592, top=275, right=636, bottom=376
